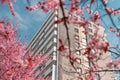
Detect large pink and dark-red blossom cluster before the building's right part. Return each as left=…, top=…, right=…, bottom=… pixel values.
left=83, top=26, right=110, bottom=61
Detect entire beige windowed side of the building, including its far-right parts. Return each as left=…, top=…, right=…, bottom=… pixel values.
left=58, top=10, right=115, bottom=80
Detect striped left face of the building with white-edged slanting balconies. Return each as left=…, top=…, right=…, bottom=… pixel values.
left=26, top=12, right=57, bottom=80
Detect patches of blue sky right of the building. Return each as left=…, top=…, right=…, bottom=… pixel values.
left=101, top=0, right=120, bottom=46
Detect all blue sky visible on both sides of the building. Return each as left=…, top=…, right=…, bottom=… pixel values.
left=0, top=0, right=120, bottom=45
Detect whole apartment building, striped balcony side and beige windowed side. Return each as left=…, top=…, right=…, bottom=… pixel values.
left=27, top=10, right=114, bottom=80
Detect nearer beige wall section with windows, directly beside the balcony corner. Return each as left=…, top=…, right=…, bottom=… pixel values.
left=58, top=11, right=89, bottom=80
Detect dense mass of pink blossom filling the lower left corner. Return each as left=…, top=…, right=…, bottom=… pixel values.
left=0, top=21, right=48, bottom=80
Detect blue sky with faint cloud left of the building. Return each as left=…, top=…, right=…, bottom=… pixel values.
left=0, top=0, right=48, bottom=42
